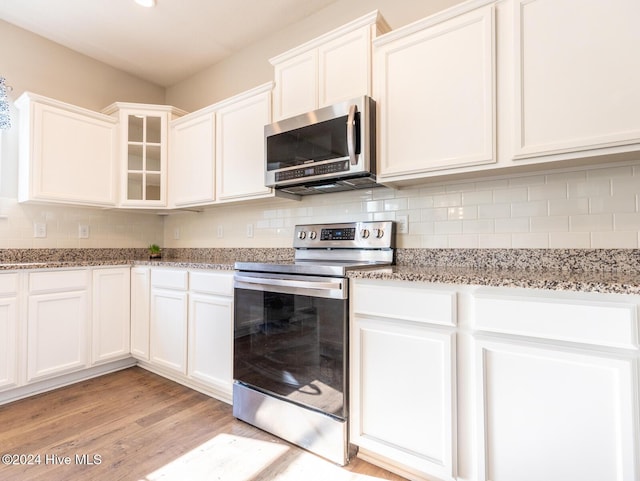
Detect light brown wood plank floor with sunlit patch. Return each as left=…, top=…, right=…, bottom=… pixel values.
left=0, top=368, right=404, bottom=481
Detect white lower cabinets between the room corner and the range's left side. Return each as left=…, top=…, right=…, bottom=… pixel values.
left=143, top=267, right=233, bottom=403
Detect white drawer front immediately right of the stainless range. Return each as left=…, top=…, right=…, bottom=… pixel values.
left=352, top=282, right=456, bottom=326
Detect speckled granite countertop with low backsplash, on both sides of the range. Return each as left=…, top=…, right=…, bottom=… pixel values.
left=0, top=248, right=640, bottom=295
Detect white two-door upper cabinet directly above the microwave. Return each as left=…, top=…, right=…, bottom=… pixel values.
left=270, top=11, right=389, bottom=120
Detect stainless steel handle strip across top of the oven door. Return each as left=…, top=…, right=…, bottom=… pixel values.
left=234, top=274, right=346, bottom=299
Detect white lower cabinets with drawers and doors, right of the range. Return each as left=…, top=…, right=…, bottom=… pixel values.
left=350, top=279, right=640, bottom=481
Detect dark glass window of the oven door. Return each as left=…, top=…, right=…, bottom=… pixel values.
left=233, top=288, right=347, bottom=418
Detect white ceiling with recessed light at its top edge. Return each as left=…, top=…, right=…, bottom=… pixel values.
left=0, top=0, right=336, bottom=87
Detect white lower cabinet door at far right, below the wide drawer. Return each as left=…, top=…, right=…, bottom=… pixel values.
left=477, top=341, right=637, bottom=481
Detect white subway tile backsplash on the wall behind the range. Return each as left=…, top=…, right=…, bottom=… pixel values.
left=164, top=156, right=640, bottom=248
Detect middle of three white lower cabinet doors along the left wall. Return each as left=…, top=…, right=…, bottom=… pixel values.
left=27, top=291, right=89, bottom=381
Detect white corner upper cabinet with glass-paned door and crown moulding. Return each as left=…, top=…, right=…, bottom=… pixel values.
left=104, top=102, right=185, bottom=208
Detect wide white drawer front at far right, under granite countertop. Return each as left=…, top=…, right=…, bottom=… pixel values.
left=474, top=291, right=638, bottom=349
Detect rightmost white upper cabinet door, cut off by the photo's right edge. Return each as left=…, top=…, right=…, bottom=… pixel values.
left=513, top=0, right=640, bottom=159
